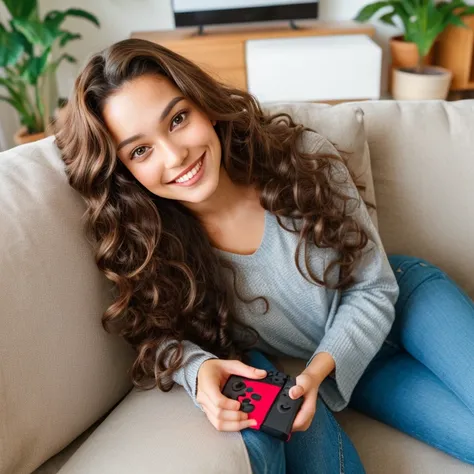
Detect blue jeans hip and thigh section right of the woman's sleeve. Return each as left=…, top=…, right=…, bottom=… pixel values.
left=350, top=255, right=474, bottom=464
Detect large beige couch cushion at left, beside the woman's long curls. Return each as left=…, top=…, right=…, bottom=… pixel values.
left=0, top=138, right=135, bottom=474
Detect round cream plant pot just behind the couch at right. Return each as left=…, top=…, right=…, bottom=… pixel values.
left=392, top=66, right=452, bottom=100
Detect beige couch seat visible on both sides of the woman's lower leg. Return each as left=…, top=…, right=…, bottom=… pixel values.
left=52, top=358, right=474, bottom=474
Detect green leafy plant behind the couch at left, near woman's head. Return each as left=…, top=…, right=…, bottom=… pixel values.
left=0, top=0, right=99, bottom=144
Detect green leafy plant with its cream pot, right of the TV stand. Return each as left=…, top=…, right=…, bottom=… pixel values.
left=355, top=0, right=474, bottom=100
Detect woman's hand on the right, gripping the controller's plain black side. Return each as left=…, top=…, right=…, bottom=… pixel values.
left=289, top=371, right=321, bottom=431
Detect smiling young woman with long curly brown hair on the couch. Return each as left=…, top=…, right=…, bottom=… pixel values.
left=57, top=40, right=474, bottom=474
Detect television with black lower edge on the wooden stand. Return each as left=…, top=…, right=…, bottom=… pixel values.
left=173, top=0, right=319, bottom=27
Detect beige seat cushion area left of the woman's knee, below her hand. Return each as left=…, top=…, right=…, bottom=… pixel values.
left=59, top=385, right=251, bottom=474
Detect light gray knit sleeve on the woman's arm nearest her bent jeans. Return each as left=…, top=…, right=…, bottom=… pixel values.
left=307, top=163, right=399, bottom=411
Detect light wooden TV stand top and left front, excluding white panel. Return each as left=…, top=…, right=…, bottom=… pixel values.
left=131, top=20, right=375, bottom=90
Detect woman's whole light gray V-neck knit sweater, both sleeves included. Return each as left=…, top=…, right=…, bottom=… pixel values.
left=165, top=174, right=398, bottom=411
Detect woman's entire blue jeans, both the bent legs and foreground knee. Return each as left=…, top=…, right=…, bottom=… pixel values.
left=241, top=255, right=474, bottom=474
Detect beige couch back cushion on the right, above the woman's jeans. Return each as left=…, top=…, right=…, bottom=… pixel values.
left=359, top=100, right=474, bottom=298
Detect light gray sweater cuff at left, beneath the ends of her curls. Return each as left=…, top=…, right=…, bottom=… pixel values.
left=157, top=341, right=217, bottom=410
